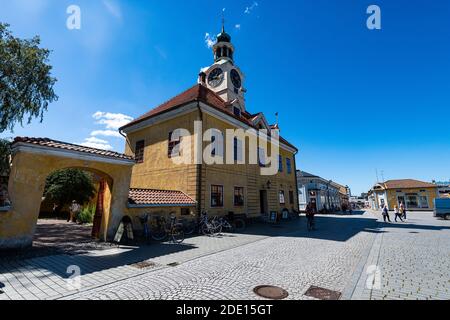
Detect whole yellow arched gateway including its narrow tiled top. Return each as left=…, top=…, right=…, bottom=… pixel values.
left=0, top=138, right=135, bottom=249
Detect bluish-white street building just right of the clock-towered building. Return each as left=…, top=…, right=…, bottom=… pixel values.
left=297, top=170, right=348, bottom=211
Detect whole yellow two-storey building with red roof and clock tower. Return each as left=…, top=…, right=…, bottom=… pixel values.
left=120, top=25, right=298, bottom=217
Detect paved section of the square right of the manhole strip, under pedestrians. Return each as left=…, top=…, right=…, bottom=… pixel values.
left=353, top=212, right=450, bottom=300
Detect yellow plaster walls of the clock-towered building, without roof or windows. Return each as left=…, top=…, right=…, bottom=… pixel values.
left=126, top=111, right=298, bottom=216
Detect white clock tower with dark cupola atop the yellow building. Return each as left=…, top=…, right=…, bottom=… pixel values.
left=199, top=24, right=246, bottom=116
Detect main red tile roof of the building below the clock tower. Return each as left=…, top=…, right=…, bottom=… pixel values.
left=119, top=84, right=297, bottom=150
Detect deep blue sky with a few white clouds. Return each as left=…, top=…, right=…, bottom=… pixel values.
left=0, top=0, right=450, bottom=193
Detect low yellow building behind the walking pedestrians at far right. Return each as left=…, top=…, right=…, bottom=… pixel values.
left=369, top=179, right=438, bottom=210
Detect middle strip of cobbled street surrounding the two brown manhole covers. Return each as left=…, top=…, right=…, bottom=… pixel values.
left=59, top=212, right=376, bottom=300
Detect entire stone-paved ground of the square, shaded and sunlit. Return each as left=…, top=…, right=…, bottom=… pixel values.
left=0, top=212, right=450, bottom=300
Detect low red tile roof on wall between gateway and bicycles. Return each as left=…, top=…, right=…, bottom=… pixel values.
left=128, top=189, right=196, bottom=207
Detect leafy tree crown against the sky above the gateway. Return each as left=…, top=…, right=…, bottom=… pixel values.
left=0, top=23, right=58, bottom=132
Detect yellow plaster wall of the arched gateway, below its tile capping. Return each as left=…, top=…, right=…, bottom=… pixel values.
left=0, top=151, right=131, bottom=249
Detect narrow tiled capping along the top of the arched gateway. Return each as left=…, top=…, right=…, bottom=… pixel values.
left=12, top=137, right=134, bottom=160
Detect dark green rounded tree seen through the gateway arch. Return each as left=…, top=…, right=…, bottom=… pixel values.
left=44, top=169, right=96, bottom=208
